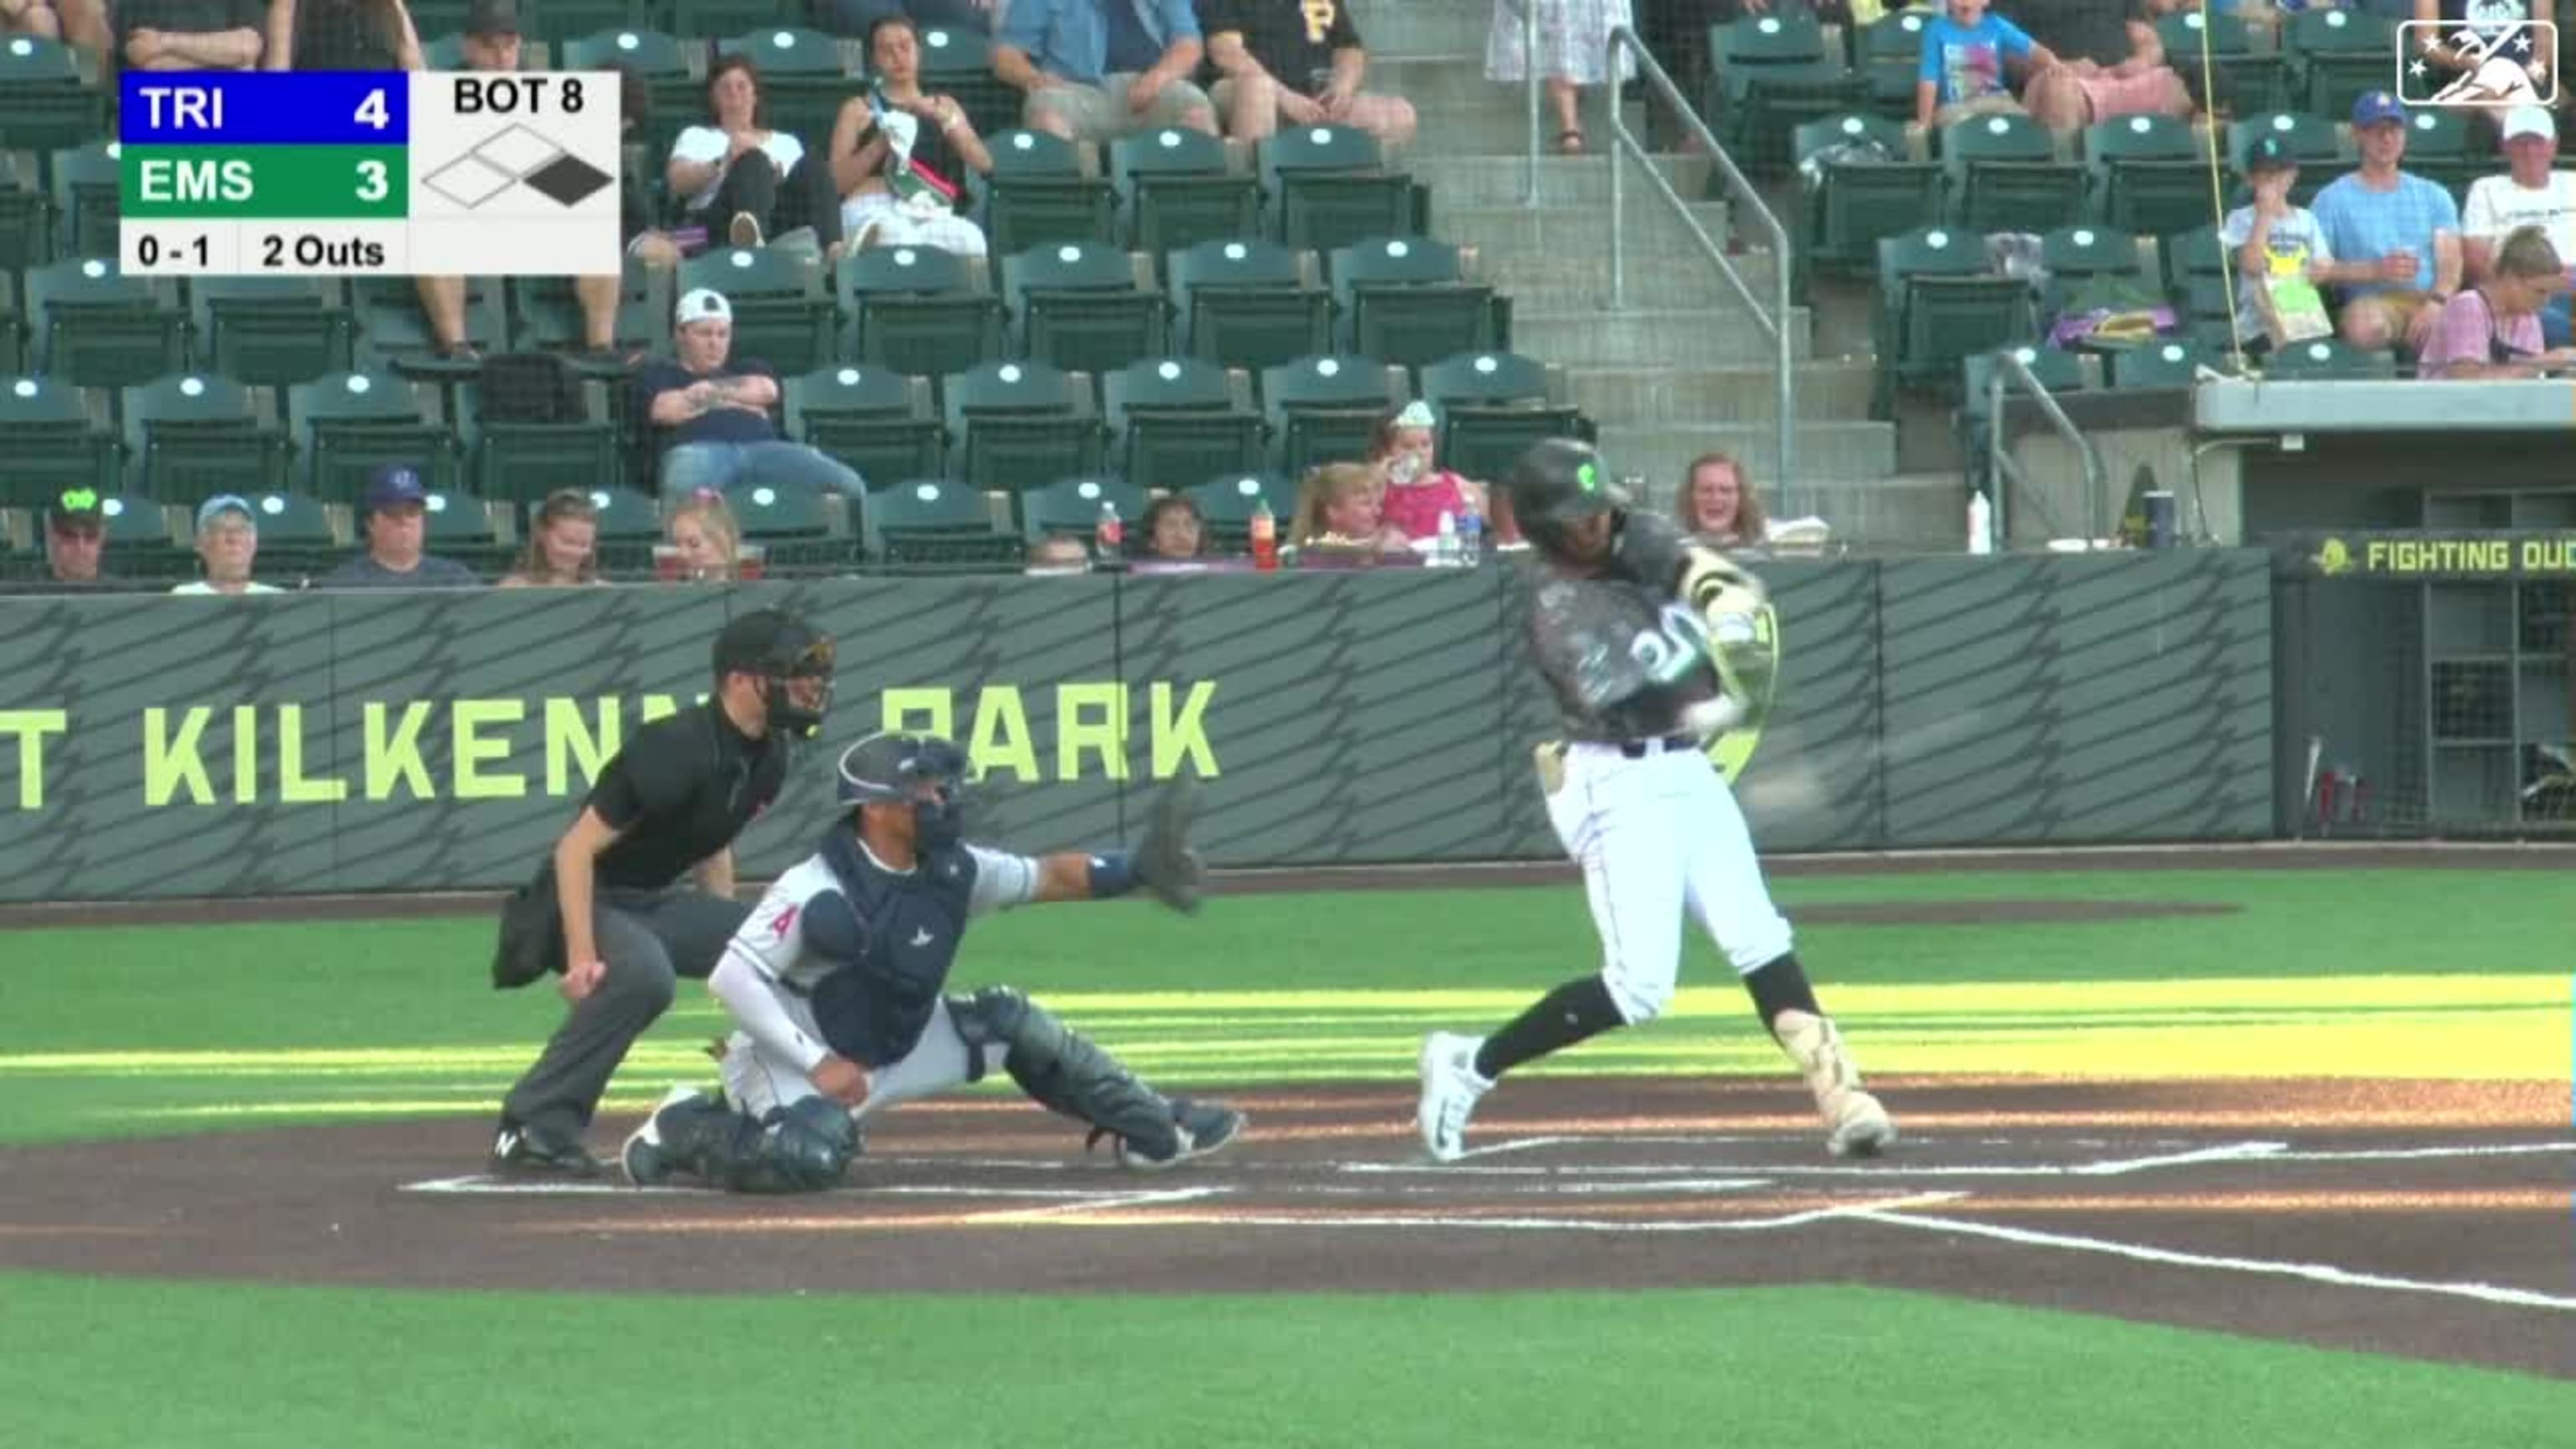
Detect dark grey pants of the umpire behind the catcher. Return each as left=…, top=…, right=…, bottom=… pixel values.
left=502, top=890, right=752, bottom=1137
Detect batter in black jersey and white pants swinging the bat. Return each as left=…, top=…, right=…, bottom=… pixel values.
left=1417, top=441, right=1896, bottom=1163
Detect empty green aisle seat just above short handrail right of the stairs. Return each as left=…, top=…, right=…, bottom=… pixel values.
left=1870, top=230, right=2035, bottom=420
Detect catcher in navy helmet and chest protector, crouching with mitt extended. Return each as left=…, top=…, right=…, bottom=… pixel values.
left=626, top=735, right=1244, bottom=1194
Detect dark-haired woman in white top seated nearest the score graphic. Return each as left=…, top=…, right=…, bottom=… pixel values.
left=662, top=55, right=839, bottom=255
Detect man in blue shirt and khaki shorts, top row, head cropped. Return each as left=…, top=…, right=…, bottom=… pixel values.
left=992, top=0, right=1216, bottom=142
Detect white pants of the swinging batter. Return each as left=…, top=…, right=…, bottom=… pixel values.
left=1548, top=743, right=1790, bottom=1026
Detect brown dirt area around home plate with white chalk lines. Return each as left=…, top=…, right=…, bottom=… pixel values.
left=0, top=1078, right=2576, bottom=1377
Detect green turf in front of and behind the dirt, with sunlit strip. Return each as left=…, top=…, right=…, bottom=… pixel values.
left=0, top=871, right=2576, bottom=1449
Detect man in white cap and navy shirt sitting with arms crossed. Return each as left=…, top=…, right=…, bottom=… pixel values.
left=636, top=286, right=865, bottom=497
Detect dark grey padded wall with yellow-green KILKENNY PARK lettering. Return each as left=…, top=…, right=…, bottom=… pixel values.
left=0, top=549, right=2275, bottom=902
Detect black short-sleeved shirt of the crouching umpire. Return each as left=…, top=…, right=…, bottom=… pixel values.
left=589, top=701, right=788, bottom=890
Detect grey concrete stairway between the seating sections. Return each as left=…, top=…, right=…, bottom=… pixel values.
left=1355, top=0, right=1961, bottom=547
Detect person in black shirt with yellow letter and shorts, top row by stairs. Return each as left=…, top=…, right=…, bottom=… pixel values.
left=1201, top=0, right=1415, bottom=147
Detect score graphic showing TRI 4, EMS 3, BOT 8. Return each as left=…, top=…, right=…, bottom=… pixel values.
left=118, top=72, right=626, bottom=276
